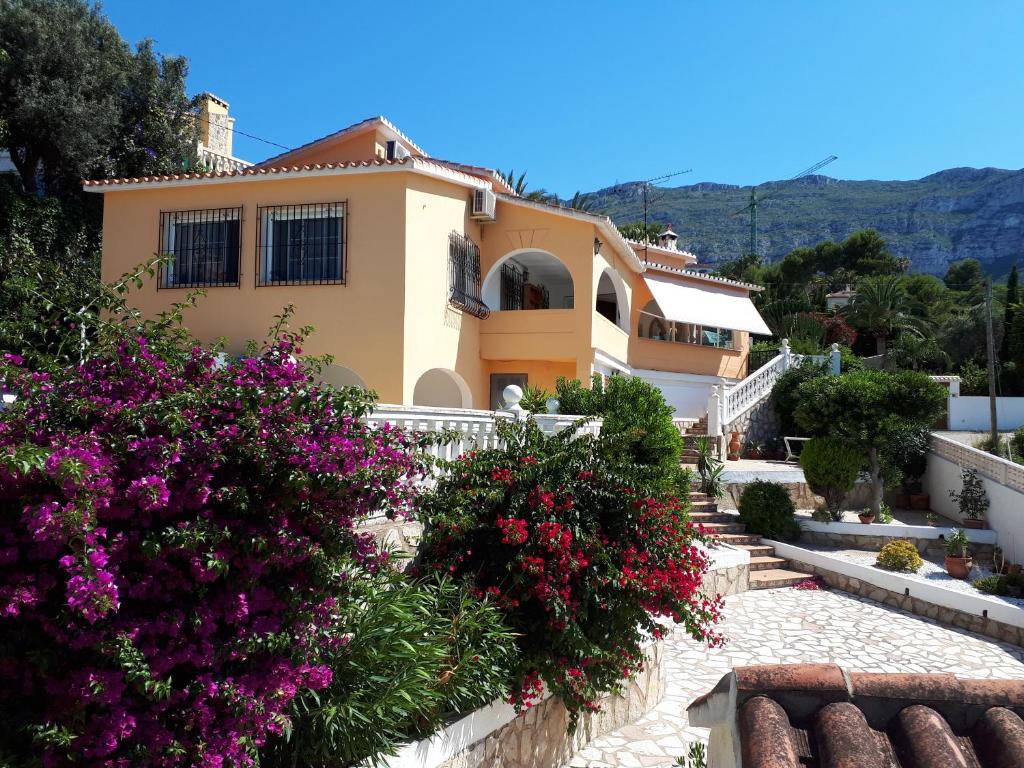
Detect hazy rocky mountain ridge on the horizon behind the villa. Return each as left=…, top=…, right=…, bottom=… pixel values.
left=589, top=166, right=1024, bottom=276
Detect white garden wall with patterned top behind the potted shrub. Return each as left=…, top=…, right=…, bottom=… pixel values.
left=924, top=435, right=1024, bottom=563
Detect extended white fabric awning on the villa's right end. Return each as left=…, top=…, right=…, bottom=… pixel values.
left=644, top=275, right=771, bottom=336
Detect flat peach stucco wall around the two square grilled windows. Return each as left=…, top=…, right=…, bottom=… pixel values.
left=102, top=172, right=409, bottom=402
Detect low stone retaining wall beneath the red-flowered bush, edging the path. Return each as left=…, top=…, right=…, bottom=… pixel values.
left=440, top=642, right=666, bottom=768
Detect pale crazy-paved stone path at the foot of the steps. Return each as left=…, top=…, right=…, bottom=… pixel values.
left=569, top=589, right=1024, bottom=768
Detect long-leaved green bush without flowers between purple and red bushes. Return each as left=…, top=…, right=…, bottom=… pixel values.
left=268, top=571, right=518, bottom=768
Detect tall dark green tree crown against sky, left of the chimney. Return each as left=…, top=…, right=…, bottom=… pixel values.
left=0, top=0, right=198, bottom=196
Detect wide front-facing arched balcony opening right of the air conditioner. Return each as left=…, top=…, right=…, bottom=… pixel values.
left=483, top=250, right=575, bottom=311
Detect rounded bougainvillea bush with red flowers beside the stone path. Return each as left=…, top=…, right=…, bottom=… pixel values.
left=419, top=423, right=720, bottom=722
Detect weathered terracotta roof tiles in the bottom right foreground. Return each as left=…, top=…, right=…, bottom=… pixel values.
left=688, top=664, right=1024, bottom=768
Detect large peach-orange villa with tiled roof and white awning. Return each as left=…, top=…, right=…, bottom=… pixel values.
left=85, top=115, right=769, bottom=418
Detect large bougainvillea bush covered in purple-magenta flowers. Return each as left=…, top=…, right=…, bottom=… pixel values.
left=0, top=317, right=438, bottom=767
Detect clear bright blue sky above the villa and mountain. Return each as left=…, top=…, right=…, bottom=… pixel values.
left=103, top=0, right=1024, bottom=196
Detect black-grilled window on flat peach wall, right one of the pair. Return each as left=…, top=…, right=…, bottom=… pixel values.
left=256, top=203, right=347, bottom=286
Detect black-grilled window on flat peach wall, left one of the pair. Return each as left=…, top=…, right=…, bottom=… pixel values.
left=157, top=208, right=242, bottom=288
